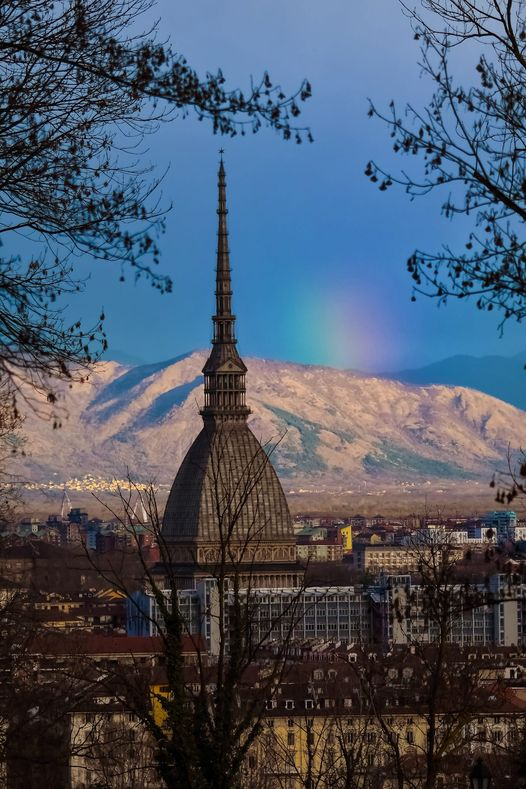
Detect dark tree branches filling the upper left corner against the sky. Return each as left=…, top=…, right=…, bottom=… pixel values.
left=0, top=0, right=310, bottom=401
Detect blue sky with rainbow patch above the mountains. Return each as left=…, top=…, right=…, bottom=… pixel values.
left=66, top=0, right=526, bottom=371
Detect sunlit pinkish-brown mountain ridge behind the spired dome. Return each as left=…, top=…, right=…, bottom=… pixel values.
left=17, top=351, right=526, bottom=488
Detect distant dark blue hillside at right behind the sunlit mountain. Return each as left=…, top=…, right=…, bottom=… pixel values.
left=388, top=351, right=526, bottom=410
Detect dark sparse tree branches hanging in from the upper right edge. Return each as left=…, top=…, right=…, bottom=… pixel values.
left=365, top=0, right=526, bottom=330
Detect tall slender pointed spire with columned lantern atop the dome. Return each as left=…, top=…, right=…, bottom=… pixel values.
left=201, top=155, right=250, bottom=422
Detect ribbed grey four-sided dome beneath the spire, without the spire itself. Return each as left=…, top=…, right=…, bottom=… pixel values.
left=163, top=422, right=293, bottom=544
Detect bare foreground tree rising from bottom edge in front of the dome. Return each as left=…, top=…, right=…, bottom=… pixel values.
left=88, top=428, right=304, bottom=789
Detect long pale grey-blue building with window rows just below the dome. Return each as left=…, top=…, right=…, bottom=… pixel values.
left=127, top=574, right=526, bottom=654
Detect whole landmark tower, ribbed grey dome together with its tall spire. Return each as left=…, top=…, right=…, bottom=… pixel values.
left=162, top=158, right=302, bottom=587
